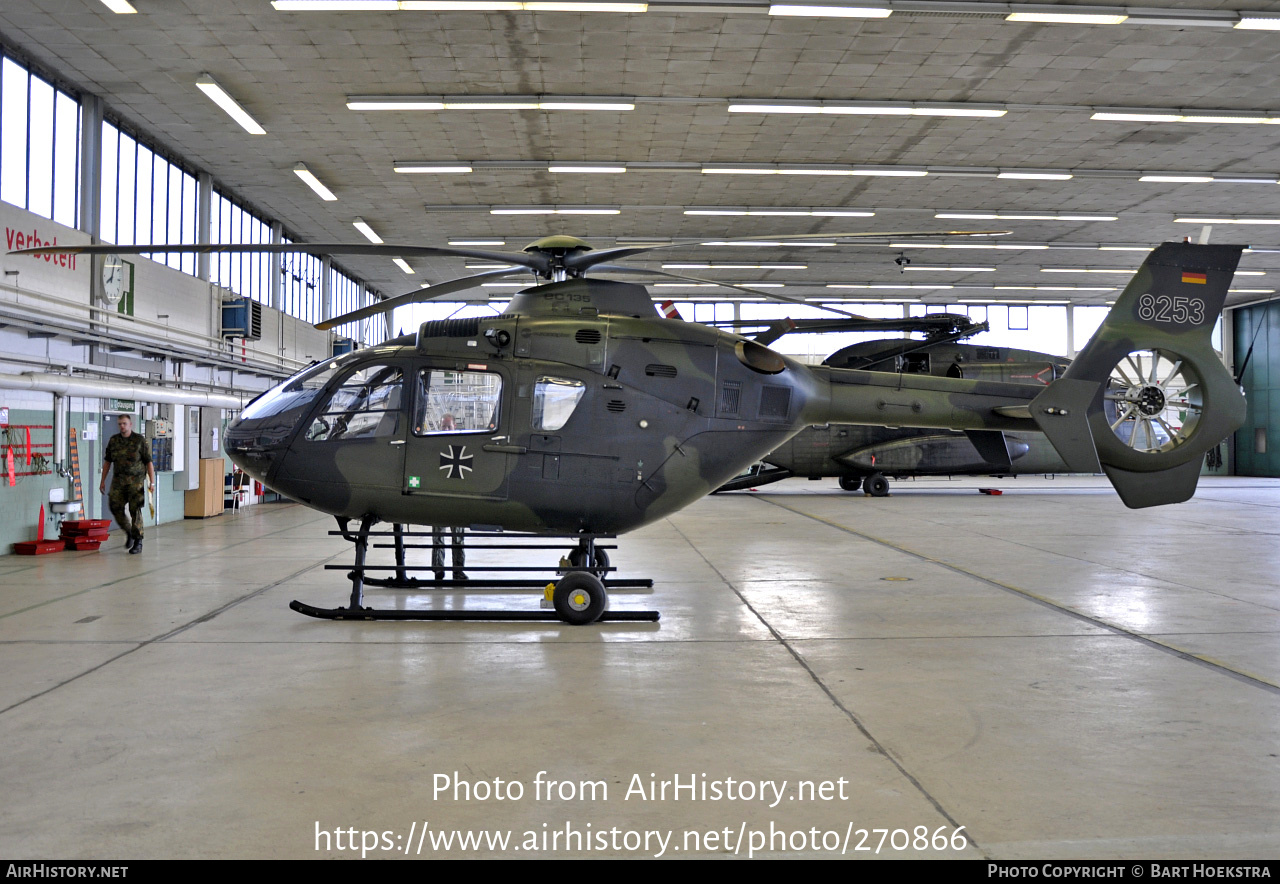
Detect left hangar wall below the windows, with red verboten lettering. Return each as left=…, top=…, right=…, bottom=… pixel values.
left=0, top=202, right=333, bottom=554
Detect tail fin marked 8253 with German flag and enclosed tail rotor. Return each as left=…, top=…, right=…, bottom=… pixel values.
left=1030, top=243, right=1244, bottom=509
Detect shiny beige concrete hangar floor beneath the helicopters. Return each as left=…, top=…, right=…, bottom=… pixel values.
left=0, top=478, right=1280, bottom=858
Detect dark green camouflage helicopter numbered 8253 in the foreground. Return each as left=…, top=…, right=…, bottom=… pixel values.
left=15, top=234, right=1244, bottom=623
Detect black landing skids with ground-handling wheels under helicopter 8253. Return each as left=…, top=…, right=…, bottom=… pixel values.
left=289, top=517, right=660, bottom=624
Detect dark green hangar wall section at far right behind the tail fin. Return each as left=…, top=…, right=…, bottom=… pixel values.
left=1233, top=301, right=1280, bottom=477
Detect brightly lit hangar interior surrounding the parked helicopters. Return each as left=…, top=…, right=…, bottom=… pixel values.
left=0, top=0, right=1280, bottom=858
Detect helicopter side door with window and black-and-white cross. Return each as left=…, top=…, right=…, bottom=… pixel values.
left=403, top=365, right=511, bottom=500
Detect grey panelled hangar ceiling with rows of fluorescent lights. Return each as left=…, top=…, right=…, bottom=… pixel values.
left=0, top=0, right=1280, bottom=310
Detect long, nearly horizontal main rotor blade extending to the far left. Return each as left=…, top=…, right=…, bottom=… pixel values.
left=9, top=243, right=550, bottom=272
